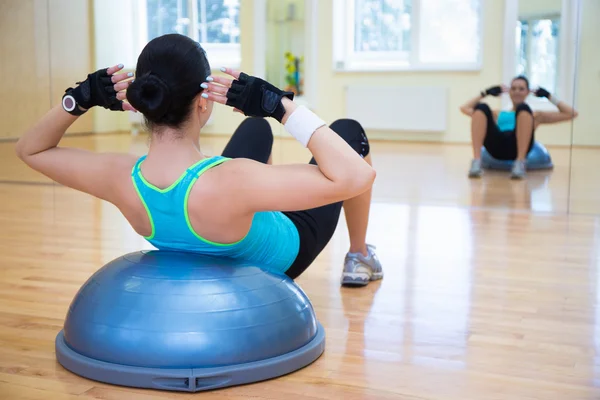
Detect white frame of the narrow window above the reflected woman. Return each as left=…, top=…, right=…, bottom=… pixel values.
left=502, top=0, right=582, bottom=111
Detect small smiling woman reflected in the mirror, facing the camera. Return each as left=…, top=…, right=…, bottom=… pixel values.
left=460, top=76, right=577, bottom=179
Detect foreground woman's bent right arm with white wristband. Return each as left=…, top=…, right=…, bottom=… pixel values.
left=202, top=71, right=375, bottom=212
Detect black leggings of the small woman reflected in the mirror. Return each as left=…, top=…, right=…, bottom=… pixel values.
left=475, top=103, right=535, bottom=160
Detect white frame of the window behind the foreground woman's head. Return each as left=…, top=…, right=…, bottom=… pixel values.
left=137, top=0, right=243, bottom=70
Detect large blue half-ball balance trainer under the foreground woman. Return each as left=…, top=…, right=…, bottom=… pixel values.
left=56, top=251, right=325, bottom=391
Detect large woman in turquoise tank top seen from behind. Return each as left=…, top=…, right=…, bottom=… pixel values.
left=16, top=34, right=383, bottom=285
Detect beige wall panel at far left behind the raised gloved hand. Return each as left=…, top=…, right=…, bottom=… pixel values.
left=0, top=0, right=93, bottom=138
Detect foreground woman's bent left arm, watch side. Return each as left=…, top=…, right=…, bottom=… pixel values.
left=15, top=67, right=137, bottom=205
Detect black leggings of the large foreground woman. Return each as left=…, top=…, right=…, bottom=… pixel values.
left=222, top=118, right=369, bottom=279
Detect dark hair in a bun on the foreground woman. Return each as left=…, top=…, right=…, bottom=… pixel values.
left=127, top=34, right=210, bottom=129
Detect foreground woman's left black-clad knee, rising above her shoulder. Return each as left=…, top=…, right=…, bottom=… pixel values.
left=221, top=117, right=273, bottom=164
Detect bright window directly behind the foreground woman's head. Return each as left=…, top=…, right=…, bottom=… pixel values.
left=142, top=0, right=241, bottom=68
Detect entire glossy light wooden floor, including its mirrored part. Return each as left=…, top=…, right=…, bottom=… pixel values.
left=0, top=135, right=600, bottom=400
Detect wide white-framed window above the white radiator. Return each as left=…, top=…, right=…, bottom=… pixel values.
left=333, top=0, right=481, bottom=70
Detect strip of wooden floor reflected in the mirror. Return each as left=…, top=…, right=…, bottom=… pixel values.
left=0, top=132, right=576, bottom=213
